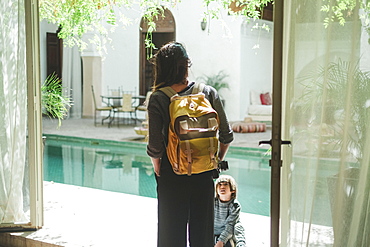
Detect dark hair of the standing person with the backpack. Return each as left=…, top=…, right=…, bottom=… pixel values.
left=153, top=41, right=190, bottom=91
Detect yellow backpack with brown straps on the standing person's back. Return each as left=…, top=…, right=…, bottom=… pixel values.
left=160, top=83, right=219, bottom=176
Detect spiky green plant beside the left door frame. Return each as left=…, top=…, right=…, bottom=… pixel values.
left=41, top=73, right=72, bottom=127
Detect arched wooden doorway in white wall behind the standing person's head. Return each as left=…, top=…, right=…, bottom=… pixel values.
left=139, top=9, right=176, bottom=95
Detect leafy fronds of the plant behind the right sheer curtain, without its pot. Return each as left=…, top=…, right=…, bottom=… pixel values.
left=299, top=59, right=370, bottom=161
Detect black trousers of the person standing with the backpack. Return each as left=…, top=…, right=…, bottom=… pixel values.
left=156, top=166, right=214, bottom=247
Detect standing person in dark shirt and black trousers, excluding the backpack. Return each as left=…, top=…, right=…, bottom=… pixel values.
left=147, top=42, right=233, bottom=247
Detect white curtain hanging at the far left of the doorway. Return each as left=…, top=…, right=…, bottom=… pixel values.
left=0, top=0, right=28, bottom=223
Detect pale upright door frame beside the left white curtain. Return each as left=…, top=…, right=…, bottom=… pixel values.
left=25, top=0, right=44, bottom=229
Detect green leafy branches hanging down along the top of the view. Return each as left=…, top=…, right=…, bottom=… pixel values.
left=39, top=0, right=370, bottom=54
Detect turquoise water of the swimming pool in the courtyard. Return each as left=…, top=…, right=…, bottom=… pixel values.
left=44, top=135, right=270, bottom=216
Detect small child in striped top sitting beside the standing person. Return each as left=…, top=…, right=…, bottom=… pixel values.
left=214, top=175, right=246, bottom=247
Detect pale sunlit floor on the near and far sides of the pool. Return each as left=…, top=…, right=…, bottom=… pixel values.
left=0, top=119, right=271, bottom=247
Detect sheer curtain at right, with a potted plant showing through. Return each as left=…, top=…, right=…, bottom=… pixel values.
left=281, top=0, right=370, bottom=247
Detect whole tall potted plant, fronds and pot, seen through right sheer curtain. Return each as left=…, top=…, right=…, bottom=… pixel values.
left=299, top=60, right=370, bottom=246
